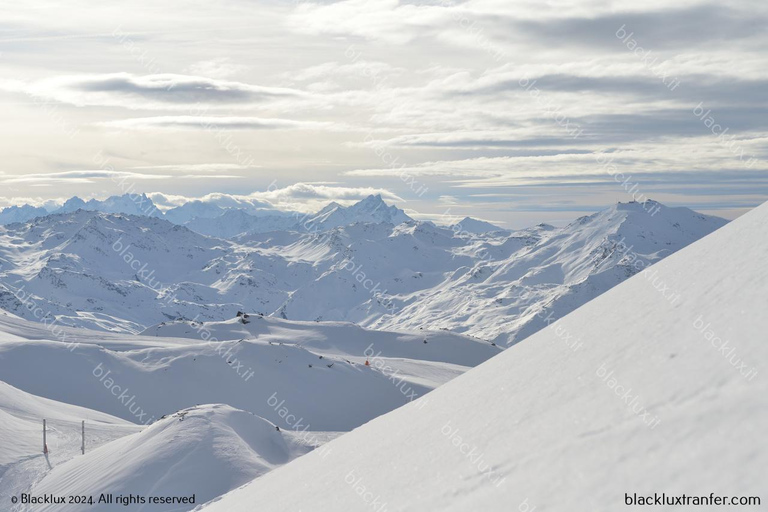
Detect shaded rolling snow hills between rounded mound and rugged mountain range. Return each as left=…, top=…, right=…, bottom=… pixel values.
left=0, top=317, right=499, bottom=431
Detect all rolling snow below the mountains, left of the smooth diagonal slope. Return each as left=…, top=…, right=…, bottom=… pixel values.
left=0, top=313, right=492, bottom=512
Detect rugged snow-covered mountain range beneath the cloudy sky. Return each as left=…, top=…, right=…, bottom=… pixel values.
left=0, top=196, right=726, bottom=346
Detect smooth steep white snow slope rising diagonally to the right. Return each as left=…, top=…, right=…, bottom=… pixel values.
left=202, top=204, right=768, bottom=512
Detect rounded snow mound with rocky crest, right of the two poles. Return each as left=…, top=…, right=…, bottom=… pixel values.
left=18, top=405, right=324, bottom=511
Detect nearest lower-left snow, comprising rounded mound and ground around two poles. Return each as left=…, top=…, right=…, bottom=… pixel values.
left=0, top=382, right=338, bottom=512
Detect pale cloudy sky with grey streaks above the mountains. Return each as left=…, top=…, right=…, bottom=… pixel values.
left=0, top=0, right=768, bottom=227
